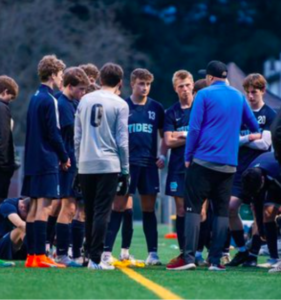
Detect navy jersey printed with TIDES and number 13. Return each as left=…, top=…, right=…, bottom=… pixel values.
left=126, top=98, right=164, bottom=167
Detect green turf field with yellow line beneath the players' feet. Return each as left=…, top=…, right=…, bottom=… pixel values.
left=0, top=225, right=281, bottom=299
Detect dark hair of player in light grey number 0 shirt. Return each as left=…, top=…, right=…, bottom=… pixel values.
left=100, top=63, right=124, bottom=87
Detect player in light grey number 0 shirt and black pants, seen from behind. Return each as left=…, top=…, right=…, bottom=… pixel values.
left=74, top=63, right=129, bottom=270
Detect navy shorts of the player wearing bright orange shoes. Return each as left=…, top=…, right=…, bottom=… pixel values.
left=21, top=173, right=60, bottom=199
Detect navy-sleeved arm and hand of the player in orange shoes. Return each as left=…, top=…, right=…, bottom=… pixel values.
left=45, top=101, right=70, bottom=169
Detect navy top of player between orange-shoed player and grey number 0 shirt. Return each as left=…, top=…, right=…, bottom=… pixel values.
left=58, top=94, right=78, bottom=172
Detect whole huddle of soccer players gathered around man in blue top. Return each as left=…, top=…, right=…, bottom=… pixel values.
left=0, top=55, right=281, bottom=273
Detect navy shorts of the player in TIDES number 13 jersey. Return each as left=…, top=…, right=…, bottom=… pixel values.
left=129, top=165, right=159, bottom=195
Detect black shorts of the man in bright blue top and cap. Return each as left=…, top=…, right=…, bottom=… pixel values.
left=184, top=162, right=233, bottom=217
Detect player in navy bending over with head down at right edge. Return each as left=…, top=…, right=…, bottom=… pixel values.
left=242, top=152, right=281, bottom=268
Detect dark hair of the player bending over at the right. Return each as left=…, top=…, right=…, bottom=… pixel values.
left=242, top=168, right=263, bottom=196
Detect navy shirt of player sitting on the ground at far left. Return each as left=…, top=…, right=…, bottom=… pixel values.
left=0, top=198, right=20, bottom=238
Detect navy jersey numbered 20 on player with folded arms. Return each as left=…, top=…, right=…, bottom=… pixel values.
left=237, top=104, right=276, bottom=173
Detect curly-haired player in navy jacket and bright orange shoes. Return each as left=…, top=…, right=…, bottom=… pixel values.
left=22, top=55, right=70, bottom=268
